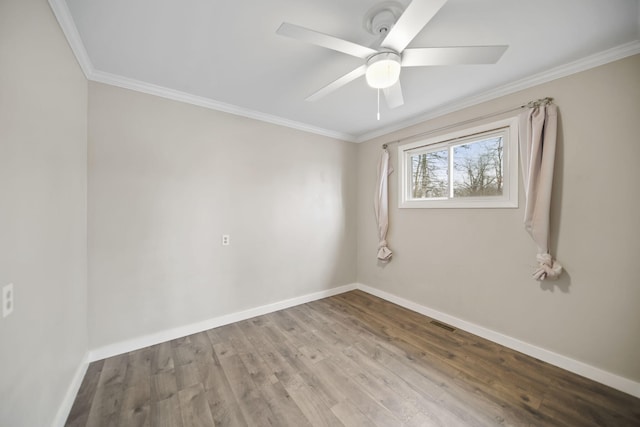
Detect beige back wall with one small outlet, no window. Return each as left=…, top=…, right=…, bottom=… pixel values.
left=88, top=83, right=357, bottom=348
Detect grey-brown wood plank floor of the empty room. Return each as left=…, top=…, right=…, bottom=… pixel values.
left=66, top=291, right=640, bottom=427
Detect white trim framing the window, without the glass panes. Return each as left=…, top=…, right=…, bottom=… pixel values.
left=398, top=116, right=519, bottom=208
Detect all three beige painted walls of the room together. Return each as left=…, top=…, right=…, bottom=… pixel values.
left=0, top=0, right=640, bottom=426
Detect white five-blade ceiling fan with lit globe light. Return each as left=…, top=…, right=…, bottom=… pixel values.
left=276, top=0, right=508, bottom=108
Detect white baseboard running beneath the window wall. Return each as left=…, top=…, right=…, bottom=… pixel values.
left=356, top=283, right=640, bottom=398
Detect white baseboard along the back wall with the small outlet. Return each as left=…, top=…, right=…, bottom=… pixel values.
left=89, top=284, right=356, bottom=362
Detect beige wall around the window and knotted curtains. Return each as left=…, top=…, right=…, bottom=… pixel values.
left=358, top=55, right=640, bottom=381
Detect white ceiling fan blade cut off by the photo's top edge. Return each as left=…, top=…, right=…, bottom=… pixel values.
left=381, top=0, right=447, bottom=52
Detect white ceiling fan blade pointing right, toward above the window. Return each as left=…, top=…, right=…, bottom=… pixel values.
left=402, top=46, right=509, bottom=67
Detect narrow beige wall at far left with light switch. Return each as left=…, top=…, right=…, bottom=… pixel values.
left=0, top=0, right=87, bottom=426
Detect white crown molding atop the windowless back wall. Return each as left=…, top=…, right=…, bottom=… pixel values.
left=89, top=71, right=356, bottom=142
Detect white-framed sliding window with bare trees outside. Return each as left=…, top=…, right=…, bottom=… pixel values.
left=398, top=117, right=518, bottom=208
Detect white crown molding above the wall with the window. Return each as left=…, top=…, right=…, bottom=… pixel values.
left=355, top=40, right=640, bottom=143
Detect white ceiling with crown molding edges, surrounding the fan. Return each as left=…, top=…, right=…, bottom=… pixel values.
left=57, top=0, right=640, bottom=141
